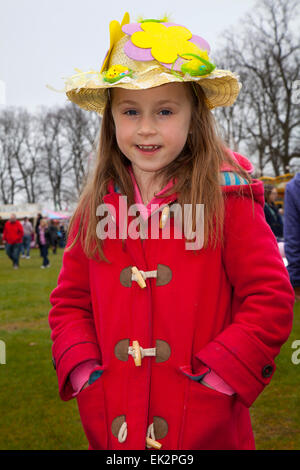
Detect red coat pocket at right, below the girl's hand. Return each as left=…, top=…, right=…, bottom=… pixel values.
left=180, top=369, right=240, bottom=450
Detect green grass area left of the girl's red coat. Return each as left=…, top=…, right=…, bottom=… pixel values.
left=0, top=250, right=87, bottom=450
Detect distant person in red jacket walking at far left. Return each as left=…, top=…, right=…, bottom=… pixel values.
left=2, top=214, right=24, bottom=269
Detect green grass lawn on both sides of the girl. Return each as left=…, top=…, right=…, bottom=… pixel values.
left=0, top=246, right=300, bottom=450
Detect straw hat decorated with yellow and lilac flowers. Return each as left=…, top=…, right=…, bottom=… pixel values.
left=64, top=13, right=241, bottom=114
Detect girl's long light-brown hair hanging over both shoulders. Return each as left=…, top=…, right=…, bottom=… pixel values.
left=67, top=83, right=252, bottom=261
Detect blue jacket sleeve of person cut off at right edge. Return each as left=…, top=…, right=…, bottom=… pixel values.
left=284, top=184, right=300, bottom=287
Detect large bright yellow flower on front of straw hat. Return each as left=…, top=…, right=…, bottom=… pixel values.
left=131, top=21, right=200, bottom=64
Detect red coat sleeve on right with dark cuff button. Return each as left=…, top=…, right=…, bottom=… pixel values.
left=196, top=195, right=294, bottom=407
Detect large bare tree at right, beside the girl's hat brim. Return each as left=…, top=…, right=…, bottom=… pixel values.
left=216, top=0, right=300, bottom=175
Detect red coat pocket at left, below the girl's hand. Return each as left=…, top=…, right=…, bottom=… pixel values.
left=76, top=366, right=108, bottom=450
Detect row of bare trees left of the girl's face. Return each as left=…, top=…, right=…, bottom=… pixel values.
left=0, top=105, right=100, bottom=209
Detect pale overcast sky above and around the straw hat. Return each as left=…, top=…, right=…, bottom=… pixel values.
left=0, top=0, right=256, bottom=111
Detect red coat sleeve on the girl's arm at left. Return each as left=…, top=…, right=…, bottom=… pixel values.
left=49, top=220, right=101, bottom=401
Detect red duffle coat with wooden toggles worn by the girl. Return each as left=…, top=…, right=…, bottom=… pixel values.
left=49, top=156, right=294, bottom=450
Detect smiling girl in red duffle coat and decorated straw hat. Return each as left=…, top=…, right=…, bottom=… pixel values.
left=49, top=14, right=294, bottom=450
